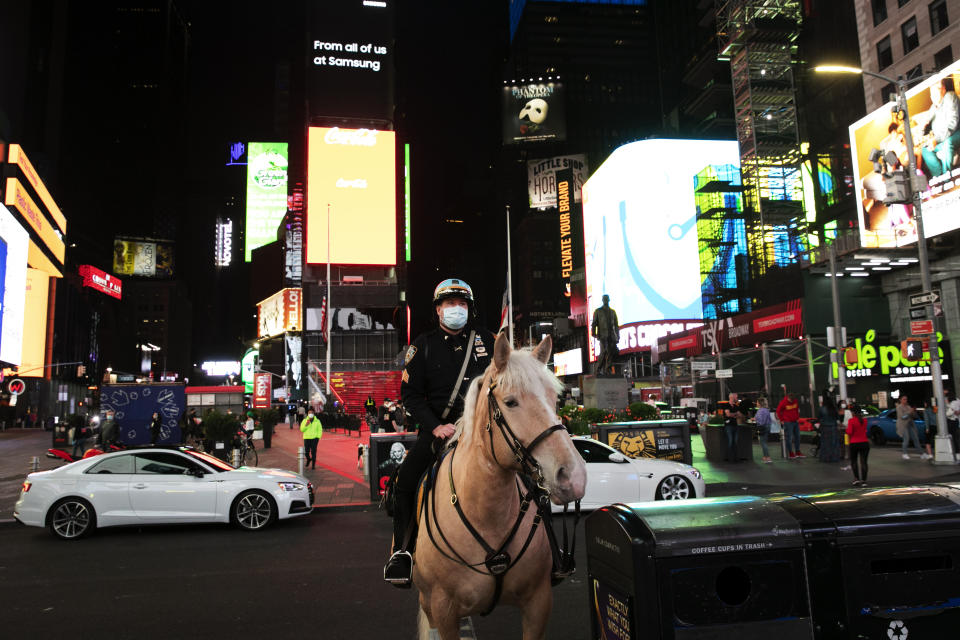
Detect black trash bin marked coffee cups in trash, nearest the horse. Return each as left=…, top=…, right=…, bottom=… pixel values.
left=585, top=496, right=814, bottom=640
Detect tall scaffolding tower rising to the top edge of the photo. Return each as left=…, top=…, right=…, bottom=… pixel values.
left=717, top=0, right=807, bottom=281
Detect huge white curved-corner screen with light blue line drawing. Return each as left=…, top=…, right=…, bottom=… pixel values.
left=583, top=140, right=740, bottom=361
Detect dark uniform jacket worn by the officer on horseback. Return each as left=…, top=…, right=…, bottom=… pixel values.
left=400, top=327, right=495, bottom=439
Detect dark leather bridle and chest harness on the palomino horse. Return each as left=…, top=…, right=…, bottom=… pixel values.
left=426, top=380, right=580, bottom=616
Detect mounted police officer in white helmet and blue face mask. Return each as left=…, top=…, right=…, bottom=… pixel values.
left=383, top=278, right=495, bottom=587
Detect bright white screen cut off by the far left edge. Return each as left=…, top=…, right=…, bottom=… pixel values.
left=0, top=205, right=28, bottom=365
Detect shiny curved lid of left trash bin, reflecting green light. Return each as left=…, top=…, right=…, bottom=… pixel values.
left=625, top=496, right=802, bottom=557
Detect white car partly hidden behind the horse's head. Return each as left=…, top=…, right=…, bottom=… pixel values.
left=553, top=436, right=707, bottom=511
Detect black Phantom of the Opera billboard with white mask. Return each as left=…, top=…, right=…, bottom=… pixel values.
left=501, top=78, right=567, bottom=144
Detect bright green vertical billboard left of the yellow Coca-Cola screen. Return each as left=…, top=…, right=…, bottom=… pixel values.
left=243, top=142, right=287, bottom=262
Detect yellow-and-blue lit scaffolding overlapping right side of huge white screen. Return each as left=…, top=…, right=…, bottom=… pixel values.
left=693, top=164, right=752, bottom=318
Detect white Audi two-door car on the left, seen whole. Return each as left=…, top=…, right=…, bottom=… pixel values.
left=13, top=447, right=313, bottom=540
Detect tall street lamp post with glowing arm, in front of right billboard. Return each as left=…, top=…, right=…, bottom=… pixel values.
left=814, top=65, right=955, bottom=464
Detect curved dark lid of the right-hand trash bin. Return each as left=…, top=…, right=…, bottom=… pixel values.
left=794, top=485, right=960, bottom=544
